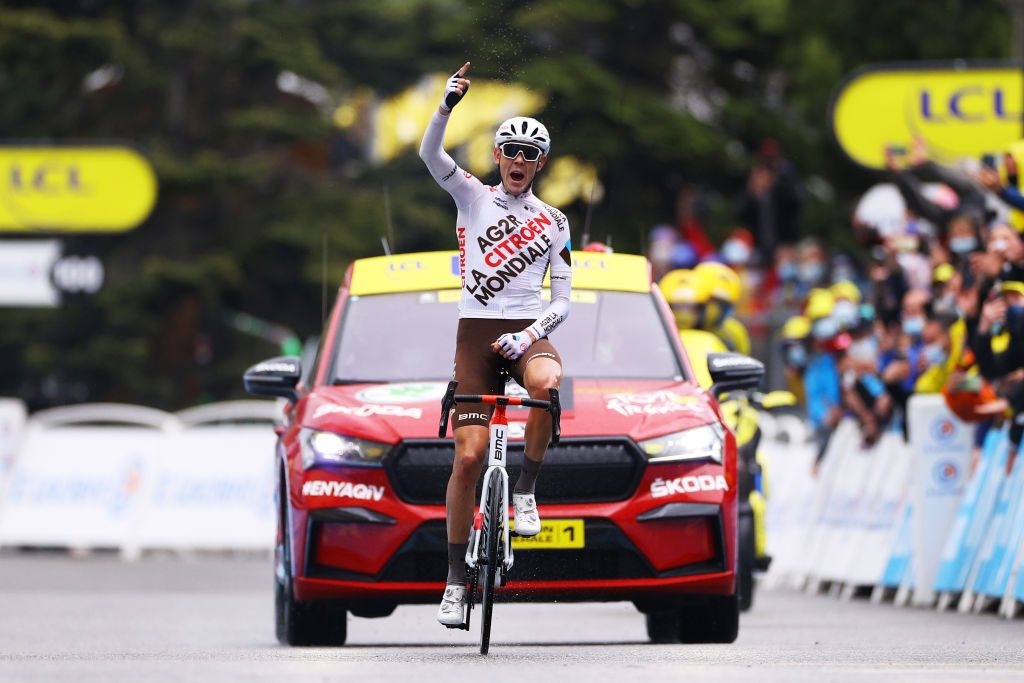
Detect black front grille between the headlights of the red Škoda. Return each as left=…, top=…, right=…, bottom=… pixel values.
left=385, top=438, right=646, bottom=505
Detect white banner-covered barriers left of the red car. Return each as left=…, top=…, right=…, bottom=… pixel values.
left=0, top=400, right=276, bottom=558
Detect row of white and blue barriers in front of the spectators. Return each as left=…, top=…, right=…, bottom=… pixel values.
left=762, top=394, right=1024, bottom=618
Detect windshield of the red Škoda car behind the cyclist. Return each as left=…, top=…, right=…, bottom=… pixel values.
left=332, top=290, right=684, bottom=383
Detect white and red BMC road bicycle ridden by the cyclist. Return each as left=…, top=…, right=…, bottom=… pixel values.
left=437, top=380, right=561, bottom=654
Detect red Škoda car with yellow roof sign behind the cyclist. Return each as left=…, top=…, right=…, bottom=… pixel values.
left=245, top=252, right=764, bottom=645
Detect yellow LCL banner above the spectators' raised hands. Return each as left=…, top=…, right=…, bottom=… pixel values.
left=830, top=63, right=1024, bottom=168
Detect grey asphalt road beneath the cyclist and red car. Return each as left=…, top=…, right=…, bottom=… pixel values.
left=0, top=555, right=1024, bottom=683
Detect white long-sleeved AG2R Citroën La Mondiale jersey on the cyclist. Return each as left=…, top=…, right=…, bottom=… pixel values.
left=420, top=112, right=572, bottom=339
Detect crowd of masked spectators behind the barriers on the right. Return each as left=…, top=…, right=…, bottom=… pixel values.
left=651, top=136, right=1024, bottom=479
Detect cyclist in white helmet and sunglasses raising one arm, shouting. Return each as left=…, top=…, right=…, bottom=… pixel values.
left=420, top=61, right=572, bottom=626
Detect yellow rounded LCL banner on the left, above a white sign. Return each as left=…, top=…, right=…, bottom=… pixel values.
left=0, top=146, right=157, bottom=232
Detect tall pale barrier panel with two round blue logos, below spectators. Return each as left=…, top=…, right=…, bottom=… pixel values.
left=907, top=394, right=974, bottom=605
